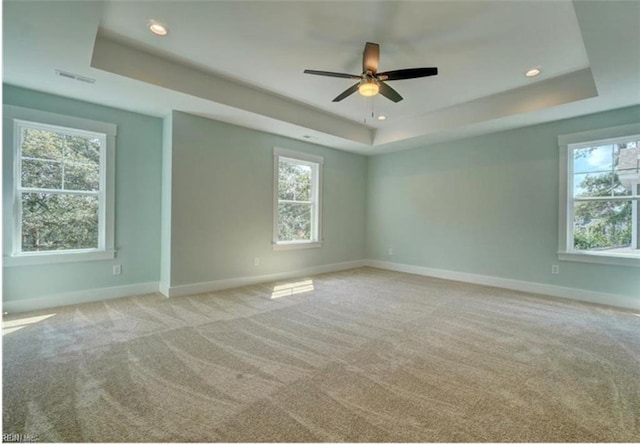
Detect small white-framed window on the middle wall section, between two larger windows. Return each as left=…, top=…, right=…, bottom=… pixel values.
left=273, top=148, right=323, bottom=250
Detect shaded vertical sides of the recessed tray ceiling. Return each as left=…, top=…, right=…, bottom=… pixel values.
left=91, top=30, right=597, bottom=153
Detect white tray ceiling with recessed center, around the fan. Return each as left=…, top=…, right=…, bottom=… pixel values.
left=3, top=0, right=640, bottom=154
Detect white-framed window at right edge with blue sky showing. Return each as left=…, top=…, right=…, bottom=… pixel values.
left=559, top=124, right=640, bottom=266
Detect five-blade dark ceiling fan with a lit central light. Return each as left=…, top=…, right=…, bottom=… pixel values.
left=304, top=42, right=438, bottom=103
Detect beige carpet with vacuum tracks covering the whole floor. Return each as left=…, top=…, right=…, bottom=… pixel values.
left=3, top=268, right=640, bottom=442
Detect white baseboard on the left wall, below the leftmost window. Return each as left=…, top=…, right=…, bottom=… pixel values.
left=2, top=282, right=158, bottom=313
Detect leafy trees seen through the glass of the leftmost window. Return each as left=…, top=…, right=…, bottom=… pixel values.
left=18, top=124, right=104, bottom=252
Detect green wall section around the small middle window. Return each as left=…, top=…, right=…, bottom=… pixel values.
left=171, top=112, right=367, bottom=286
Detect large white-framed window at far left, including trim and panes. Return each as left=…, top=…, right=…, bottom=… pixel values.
left=4, top=106, right=115, bottom=265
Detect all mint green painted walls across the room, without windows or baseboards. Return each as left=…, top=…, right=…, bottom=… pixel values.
left=3, top=85, right=640, bottom=303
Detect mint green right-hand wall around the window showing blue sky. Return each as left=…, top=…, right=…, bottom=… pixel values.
left=367, top=107, right=640, bottom=303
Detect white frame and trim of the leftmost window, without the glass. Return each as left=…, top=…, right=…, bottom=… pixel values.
left=3, top=105, right=117, bottom=266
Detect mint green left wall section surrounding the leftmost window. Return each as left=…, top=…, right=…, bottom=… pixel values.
left=2, top=85, right=162, bottom=301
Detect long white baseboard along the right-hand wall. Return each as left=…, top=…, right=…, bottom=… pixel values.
left=365, top=260, right=640, bottom=310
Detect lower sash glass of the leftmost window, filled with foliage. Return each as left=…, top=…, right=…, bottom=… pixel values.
left=22, top=193, right=98, bottom=251
